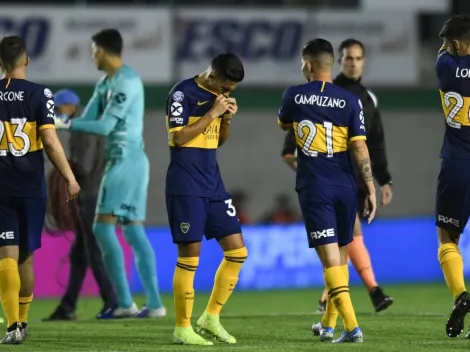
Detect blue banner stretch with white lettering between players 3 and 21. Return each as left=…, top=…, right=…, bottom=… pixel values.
left=238, top=225, right=323, bottom=289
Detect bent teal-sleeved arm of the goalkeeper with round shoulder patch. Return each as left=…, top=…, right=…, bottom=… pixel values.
left=70, top=79, right=138, bottom=136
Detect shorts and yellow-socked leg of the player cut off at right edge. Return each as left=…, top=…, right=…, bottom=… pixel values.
left=436, top=160, right=470, bottom=337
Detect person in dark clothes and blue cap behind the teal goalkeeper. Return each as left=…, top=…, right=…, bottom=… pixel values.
left=43, top=89, right=117, bottom=321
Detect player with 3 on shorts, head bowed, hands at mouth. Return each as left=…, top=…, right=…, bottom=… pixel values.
left=166, top=53, right=248, bottom=345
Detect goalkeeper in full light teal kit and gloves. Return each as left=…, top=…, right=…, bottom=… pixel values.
left=56, top=29, right=166, bottom=318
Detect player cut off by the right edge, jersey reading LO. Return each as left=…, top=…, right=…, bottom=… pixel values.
left=436, top=16, right=470, bottom=338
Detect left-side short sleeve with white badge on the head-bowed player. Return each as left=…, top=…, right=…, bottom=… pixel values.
left=166, top=88, right=191, bottom=133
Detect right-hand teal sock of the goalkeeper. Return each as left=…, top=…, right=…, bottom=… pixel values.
left=123, top=225, right=163, bottom=309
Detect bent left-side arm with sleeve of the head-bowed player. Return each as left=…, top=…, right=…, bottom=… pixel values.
left=172, top=95, right=229, bottom=147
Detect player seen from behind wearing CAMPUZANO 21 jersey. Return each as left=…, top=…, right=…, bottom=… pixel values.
left=278, top=39, right=376, bottom=343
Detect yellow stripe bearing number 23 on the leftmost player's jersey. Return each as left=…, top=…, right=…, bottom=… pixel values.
left=0, top=119, right=44, bottom=156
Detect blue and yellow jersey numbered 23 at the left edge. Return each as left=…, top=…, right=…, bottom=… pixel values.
left=0, top=79, right=55, bottom=198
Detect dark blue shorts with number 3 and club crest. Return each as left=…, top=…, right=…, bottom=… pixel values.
left=166, top=194, right=242, bottom=243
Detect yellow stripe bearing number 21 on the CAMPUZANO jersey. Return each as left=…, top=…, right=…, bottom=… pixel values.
left=294, top=120, right=349, bottom=155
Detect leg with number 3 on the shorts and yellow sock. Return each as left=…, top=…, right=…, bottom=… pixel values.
left=197, top=197, right=248, bottom=344
